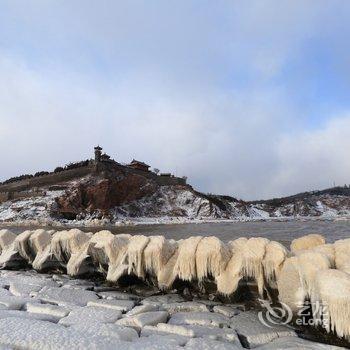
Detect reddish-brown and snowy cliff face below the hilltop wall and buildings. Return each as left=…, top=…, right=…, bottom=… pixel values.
left=0, top=165, right=350, bottom=224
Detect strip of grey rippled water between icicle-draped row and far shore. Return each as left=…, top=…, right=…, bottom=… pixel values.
left=0, top=220, right=350, bottom=244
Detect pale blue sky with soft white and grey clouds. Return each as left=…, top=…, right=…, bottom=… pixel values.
left=0, top=0, right=350, bottom=200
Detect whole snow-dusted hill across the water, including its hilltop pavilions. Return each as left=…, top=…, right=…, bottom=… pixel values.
left=0, top=148, right=350, bottom=225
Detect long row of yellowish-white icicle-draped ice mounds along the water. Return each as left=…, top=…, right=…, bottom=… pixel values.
left=0, top=229, right=350, bottom=339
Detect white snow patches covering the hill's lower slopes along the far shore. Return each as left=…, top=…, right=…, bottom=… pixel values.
left=0, top=186, right=350, bottom=227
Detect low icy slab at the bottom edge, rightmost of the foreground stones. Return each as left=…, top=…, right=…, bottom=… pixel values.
left=256, top=337, right=345, bottom=350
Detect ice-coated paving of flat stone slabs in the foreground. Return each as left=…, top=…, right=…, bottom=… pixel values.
left=0, top=271, right=340, bottom=350
